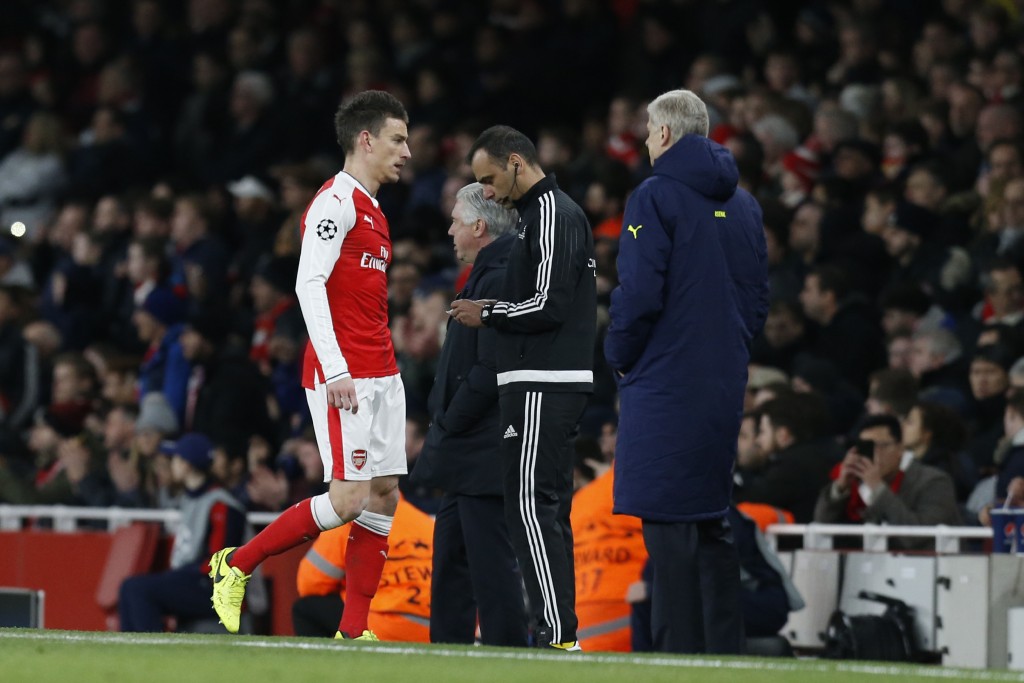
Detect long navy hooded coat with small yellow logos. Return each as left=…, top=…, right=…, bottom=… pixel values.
left=604, top=135, right=768, bottom=522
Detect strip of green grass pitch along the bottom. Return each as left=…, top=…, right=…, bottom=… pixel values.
left=0, top=629, right=1024, bottom=683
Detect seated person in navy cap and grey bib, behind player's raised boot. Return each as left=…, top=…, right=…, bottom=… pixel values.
left=118, top=432, right=246, bottom=632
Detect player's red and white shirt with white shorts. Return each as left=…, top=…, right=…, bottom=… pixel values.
left=295, top=171, right=407, bottom=481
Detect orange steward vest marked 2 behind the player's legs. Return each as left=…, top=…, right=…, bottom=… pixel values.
left=296, top=499, right=434, bottom=643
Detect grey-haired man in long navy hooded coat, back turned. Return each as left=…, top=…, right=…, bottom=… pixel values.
left=604, top=90, right=768, bottom=653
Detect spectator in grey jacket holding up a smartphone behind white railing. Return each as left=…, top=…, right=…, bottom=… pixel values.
left=814, top=415, right=962, bottom=550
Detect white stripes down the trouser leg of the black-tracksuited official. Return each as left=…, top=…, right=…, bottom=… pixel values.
left=519, top=391, right=562, bottom=643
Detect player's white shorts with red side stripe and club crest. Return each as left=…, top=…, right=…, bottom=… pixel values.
left=306, top=375, right=408, bottom=481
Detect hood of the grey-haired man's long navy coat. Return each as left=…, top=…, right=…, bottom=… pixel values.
left=653, top=134, right=739, bottom=201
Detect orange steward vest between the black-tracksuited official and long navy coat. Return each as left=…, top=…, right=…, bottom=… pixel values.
left=571, top=470, right=647, bottom=652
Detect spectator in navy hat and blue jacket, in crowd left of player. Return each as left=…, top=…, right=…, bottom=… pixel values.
left=132, top=286, right=189, bottom=419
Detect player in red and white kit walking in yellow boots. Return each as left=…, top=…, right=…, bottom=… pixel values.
left=210, top=90, right=411, bottom=640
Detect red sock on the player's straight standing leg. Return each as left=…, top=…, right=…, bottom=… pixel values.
left=338, top=523, right=388, bottom=638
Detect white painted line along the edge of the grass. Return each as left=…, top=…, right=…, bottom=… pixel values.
left=0, top=629, right=1024, bottom=681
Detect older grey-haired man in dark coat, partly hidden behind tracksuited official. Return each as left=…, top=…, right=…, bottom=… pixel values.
left=411, top=182, right=526, bottom=646
